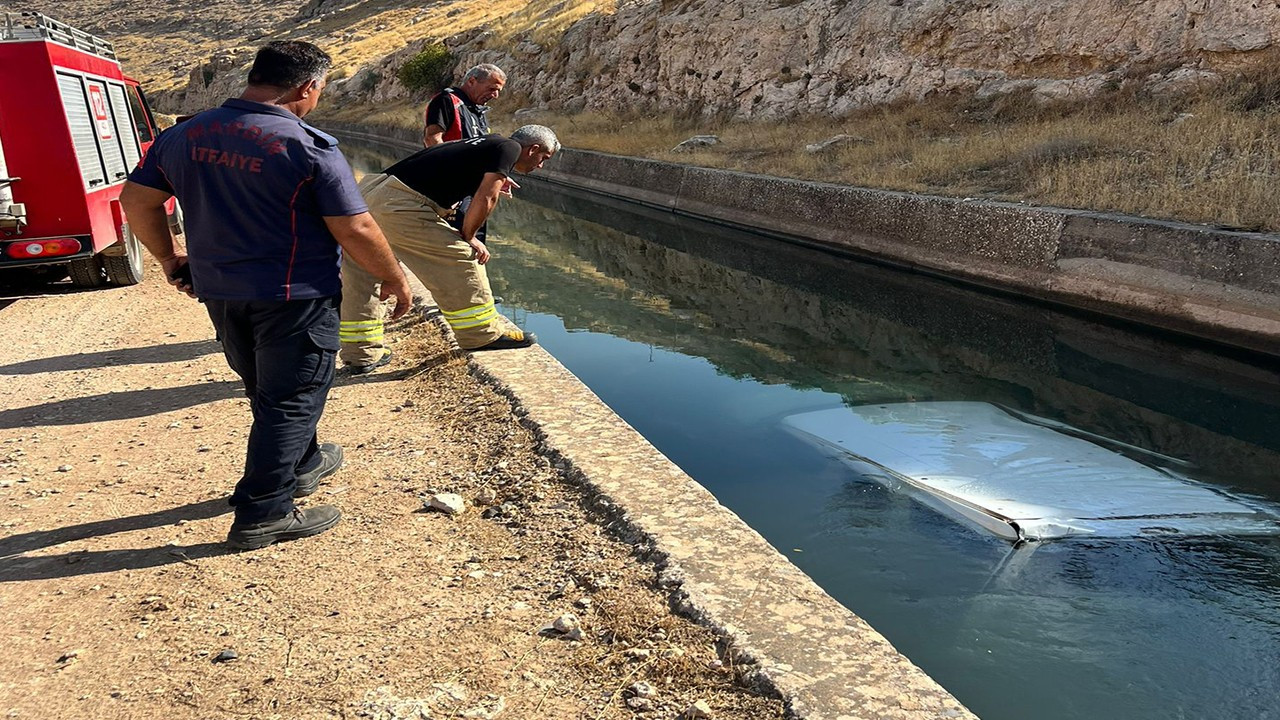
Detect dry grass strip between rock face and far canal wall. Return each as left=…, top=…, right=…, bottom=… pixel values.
left=514, top=77, right=1280, bottom=231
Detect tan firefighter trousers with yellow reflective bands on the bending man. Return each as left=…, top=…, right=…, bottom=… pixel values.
left=340, top=173, right=508, bottom=365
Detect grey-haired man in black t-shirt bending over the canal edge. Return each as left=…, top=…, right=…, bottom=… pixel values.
left=339, top=126, right=559, bottom=363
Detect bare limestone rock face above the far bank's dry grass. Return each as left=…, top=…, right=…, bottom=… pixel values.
left=452, top=0, right=1280, bottom=118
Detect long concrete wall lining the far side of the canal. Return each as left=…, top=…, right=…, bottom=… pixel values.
left=332, top=128, right=1280, bottom=355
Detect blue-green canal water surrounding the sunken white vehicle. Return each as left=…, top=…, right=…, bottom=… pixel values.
left=353, top=140, right=1280, bottom=720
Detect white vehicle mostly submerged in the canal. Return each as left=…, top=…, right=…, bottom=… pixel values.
left=783, top=402, right=1280, bottom=543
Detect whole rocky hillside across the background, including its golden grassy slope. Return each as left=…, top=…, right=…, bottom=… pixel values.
left=20, top=0, right=1280, bottom=119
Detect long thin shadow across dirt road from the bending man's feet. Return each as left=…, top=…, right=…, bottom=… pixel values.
left=0, top=352, right=452, bottom=428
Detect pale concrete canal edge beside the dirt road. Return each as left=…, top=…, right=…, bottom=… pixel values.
left=471, top=346, right=973, bottom=720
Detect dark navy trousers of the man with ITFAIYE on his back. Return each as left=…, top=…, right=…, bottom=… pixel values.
left=205, top=296, right=340, bottom=523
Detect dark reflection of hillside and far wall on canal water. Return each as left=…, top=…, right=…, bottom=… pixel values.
left=490, top=183, right=1280, bottom=493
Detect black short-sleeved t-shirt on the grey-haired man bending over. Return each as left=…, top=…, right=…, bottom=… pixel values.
left=385, top=135, right=520, bottom=208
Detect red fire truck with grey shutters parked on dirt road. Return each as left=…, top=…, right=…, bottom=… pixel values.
left=0, top=12, right=180, bottom=287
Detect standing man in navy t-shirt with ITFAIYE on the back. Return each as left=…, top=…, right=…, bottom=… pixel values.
left=120, top=41, right=412, bottom=548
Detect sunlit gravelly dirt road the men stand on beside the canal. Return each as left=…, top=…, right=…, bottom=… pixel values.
left=0, top=265, right=782, bottom=720
